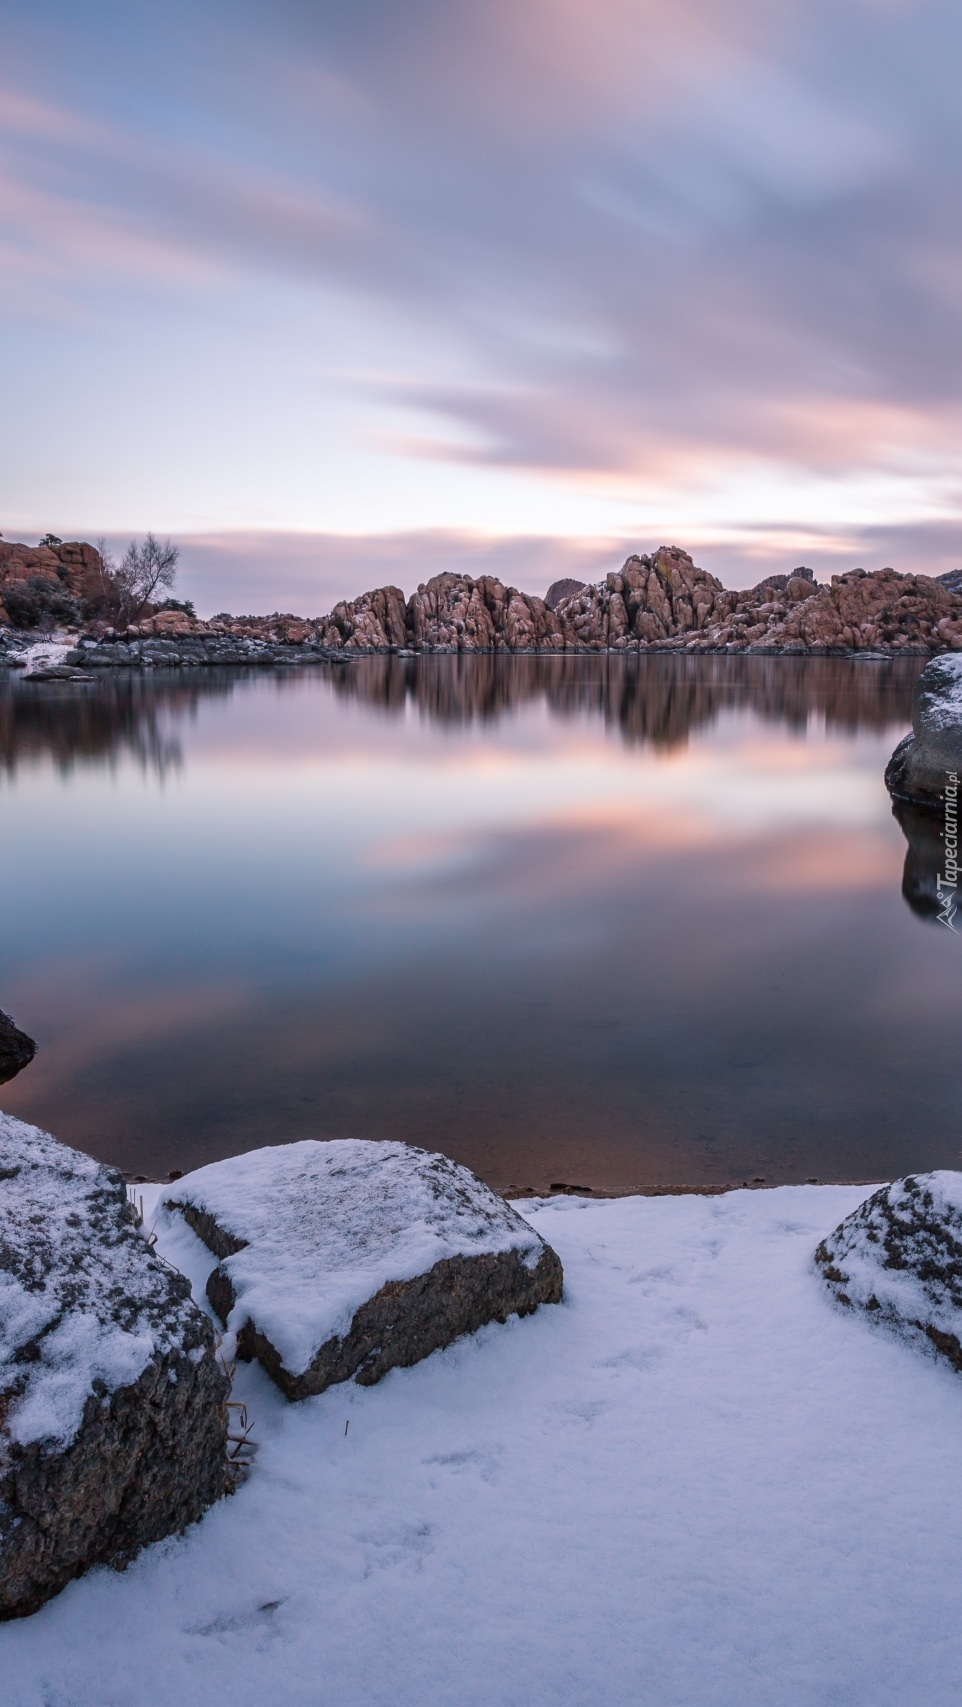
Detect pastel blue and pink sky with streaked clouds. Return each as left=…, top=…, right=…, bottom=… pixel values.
left=0, top=0, right=962, bottom=615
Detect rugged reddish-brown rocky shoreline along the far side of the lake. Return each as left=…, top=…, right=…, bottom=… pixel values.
left=0, top=543, right=962, bottom=665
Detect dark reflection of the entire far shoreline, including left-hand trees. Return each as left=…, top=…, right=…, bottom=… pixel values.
left=0, top=654, right=921, bottom=775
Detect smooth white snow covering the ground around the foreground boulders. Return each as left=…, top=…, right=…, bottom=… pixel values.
left=0, top=1186, right=962, bottom=1707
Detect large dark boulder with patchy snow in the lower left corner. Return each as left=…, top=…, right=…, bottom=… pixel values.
left=0, top=1115, right=227, bottom=1618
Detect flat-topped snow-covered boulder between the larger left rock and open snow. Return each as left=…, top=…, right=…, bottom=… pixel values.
left=162, top=1139, right=563, bottom=1398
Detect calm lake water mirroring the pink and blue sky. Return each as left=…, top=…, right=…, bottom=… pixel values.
left=0, top=655, right=962, bottom=1188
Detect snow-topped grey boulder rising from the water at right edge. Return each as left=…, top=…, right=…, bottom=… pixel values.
left=885, top=652, right=962, bottom=816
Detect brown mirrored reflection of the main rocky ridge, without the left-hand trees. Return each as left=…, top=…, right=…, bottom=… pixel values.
left=333, top=654, right=919, bottom=746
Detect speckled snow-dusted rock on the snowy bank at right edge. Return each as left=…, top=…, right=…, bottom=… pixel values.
left=815, top=1169, right=962, bottom=1372
